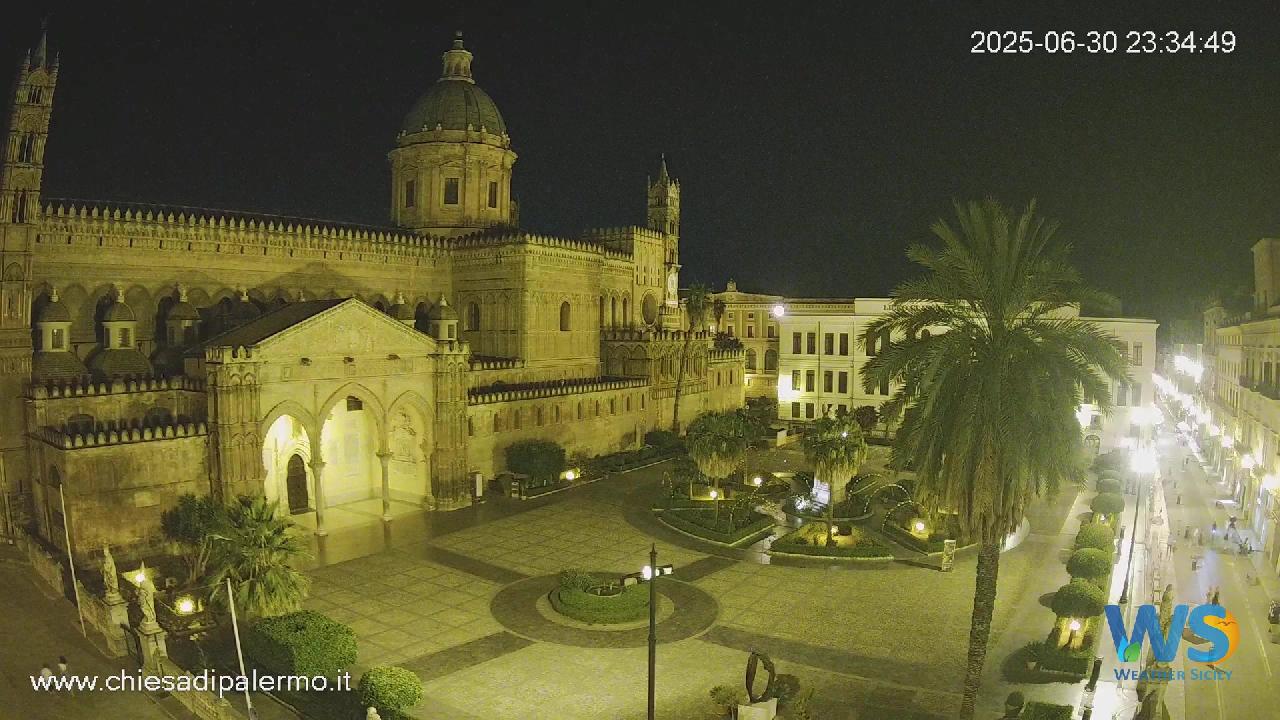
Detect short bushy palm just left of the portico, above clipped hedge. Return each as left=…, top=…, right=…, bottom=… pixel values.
left=212, top=497, right=310, bottom=618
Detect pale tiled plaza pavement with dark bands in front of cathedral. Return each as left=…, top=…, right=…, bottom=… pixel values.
left=299, top=456, right=1090, bottom=720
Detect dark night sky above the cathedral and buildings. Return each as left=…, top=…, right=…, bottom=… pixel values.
left=0, top=0, right=1280, bottom=327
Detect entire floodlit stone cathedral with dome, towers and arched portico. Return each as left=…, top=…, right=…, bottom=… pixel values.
left=0, top=30, right=745, bottom=555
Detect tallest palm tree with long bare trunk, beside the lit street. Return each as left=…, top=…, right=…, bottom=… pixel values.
left=863, top=200, right=1125, bottom=720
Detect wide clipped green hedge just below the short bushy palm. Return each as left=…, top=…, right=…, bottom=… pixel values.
left=244, top=610, right=356, bottom=676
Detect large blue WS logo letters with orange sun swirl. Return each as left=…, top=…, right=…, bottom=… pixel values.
left=1105, top=605, right=1240, bottom=662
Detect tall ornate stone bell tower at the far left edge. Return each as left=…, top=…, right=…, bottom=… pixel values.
left=0, top=22, right=58, bottom=502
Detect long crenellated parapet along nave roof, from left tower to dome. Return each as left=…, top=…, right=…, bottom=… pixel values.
left=38, top=199, right=449, bottom=256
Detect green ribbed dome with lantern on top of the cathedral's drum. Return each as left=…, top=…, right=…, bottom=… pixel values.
left=401, top=33, right=507, bottom=136
